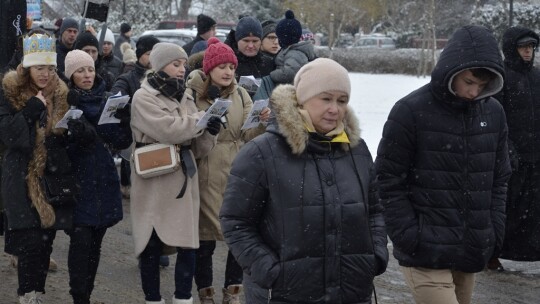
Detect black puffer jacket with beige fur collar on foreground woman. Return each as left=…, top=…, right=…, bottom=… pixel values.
left=220, top=85, right=388, bottom=304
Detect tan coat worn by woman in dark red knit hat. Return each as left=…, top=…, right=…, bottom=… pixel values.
left=186, top=70, right=265, bottom=241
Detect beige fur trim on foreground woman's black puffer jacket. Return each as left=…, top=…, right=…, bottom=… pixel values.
left=270, top=84, right=361, bottom=155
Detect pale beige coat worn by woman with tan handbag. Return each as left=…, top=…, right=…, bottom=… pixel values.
left=131, top=80, right=216, bottom=256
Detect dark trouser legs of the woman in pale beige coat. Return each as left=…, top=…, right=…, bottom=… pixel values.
left=140, top=230, right=195, bottom=301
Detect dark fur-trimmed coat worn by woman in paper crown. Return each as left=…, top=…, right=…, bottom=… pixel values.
left=0, top=66, right=73, bottom=230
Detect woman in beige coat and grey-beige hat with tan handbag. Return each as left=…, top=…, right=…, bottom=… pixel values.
left=131, top=43, right=220, bottom=304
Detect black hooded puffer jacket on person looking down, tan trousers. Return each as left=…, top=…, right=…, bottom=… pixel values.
left=376, top=26, right=511, bottom=273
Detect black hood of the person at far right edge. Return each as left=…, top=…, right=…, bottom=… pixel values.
left=502, top=26, right=540, bottom=70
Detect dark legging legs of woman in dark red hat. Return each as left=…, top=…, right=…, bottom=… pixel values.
left=195, top=241, right=243, bottom=290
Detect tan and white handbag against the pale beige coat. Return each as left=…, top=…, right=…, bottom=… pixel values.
left=133, top=143, right=181, bottom=178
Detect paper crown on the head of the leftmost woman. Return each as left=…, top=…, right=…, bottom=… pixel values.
left=23, top=34, right=56, bottom=68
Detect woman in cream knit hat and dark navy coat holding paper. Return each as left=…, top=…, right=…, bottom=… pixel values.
left=64, top=50, right=131, bottom=304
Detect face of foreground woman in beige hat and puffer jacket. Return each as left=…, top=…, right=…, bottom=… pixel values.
left=301, top=91, right=349, bottom=134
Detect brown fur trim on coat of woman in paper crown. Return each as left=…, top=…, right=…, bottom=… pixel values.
left=2, top=71, right=69, bottom=228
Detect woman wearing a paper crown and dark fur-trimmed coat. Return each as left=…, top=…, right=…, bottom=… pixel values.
left=0, top=33, right=73, bottom=303
